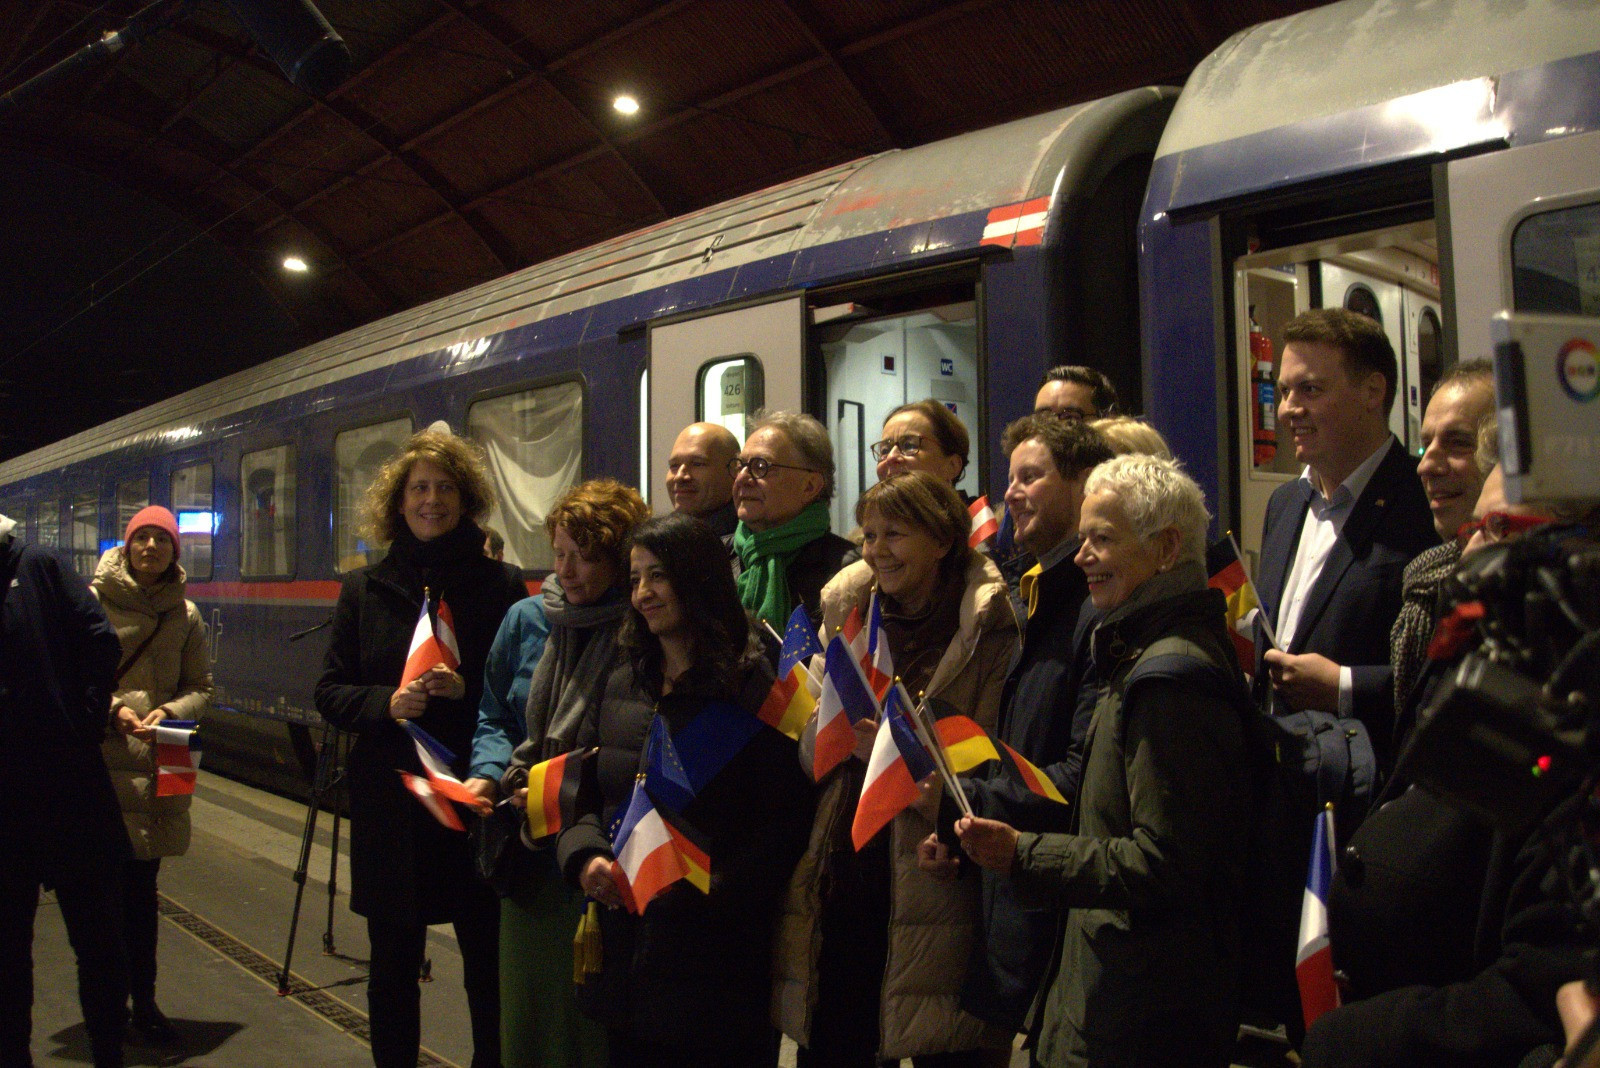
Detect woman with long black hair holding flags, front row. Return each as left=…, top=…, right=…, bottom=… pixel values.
left=560, top=513, right=811, bottom=1068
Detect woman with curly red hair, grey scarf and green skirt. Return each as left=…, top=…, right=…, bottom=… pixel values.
left=501, top=478, right=649, bottom=1068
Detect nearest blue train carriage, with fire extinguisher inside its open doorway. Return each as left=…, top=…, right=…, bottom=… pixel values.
left=1139, top=0, right=1600, bottom=556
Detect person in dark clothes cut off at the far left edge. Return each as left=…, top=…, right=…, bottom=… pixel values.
left=0, top=515, right=128, bottom=1068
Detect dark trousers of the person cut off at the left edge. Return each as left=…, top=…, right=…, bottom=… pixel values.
left=0, top=863, right=128, bottom=1068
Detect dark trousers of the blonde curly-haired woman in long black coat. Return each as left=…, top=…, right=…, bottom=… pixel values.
left=366, top=881, right=501, bottom=1068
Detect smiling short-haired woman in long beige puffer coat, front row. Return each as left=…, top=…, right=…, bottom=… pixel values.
left=774, top=472, right=1018, bottom=1068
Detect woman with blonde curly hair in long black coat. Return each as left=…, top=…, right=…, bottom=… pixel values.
left=317, top=428, right=526, bottom=1068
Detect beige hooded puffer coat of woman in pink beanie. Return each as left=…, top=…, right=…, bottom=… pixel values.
left=90, top=545, right=211, bottom=860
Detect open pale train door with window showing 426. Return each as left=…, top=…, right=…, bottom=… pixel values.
left=642, top=296, right=805, bottom=500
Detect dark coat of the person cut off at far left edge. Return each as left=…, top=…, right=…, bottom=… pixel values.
left=0, top=534, right=130, bottom=878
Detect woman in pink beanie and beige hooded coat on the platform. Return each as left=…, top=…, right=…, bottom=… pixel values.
left=90, top=505, right=211, bottom=1046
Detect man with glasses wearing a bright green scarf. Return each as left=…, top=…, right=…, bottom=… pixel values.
left=728, top=411, right=861, bottom=633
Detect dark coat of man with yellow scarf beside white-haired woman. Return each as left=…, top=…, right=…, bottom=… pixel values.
left=962, top=553, right=1094, bottom=1031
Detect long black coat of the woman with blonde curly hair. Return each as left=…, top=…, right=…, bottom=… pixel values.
left=317, top=521, right=528, bottom=924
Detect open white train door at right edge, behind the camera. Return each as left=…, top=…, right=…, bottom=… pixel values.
left=1446, top=133, right=1600, bottom=357
